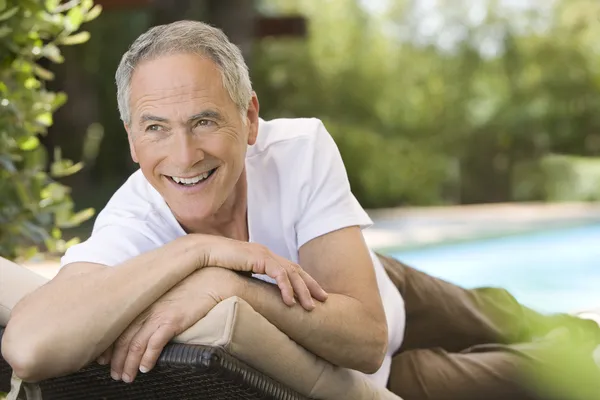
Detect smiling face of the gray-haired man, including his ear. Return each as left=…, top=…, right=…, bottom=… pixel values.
left=125, top=54, right=258, bottom=227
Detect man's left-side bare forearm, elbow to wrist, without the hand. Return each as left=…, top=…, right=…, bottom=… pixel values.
left=2, top=236, right=210, bottom=380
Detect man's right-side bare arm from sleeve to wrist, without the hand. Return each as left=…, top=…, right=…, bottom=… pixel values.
left=240, top=227, right=388, bottom=373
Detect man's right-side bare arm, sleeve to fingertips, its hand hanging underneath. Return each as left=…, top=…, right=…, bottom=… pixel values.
left=103, top=228, right=387, bottom=382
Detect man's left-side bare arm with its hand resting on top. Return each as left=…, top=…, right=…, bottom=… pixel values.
left=2, top=234, right=326, bottom=381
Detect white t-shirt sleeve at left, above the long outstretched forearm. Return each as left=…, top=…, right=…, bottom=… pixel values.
left=60, top=214, right=160, bottom=267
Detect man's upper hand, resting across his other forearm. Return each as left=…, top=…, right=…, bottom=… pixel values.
left=198, top=235, right=328, bottom=311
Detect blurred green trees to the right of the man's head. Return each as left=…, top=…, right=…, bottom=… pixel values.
left=252, top=0, right=600, bottom=207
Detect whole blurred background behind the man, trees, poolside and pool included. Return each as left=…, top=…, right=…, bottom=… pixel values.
left=0, top=0, right=600, bottom=310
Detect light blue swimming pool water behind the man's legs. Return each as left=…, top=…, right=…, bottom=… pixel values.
left=391, top=224, right=600, bottom=312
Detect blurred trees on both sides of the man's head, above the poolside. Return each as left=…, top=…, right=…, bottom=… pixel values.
left=43, top=0, right=600, bottom=212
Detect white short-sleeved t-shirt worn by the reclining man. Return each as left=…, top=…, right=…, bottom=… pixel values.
left=61, top=119, right=405, bottom=386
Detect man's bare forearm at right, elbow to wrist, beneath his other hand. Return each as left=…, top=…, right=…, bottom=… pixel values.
left=240, top=279, right=387, bottom=373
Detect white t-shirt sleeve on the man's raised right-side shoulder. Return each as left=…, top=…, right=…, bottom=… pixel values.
left=296, top=123, right=373, bottom=248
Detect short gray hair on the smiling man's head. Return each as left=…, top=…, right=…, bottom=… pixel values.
left=115, top=21, right=252, bottom=124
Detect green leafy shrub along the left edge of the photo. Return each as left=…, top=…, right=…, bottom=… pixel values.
left=0, top=0, right=101, bottom=258
